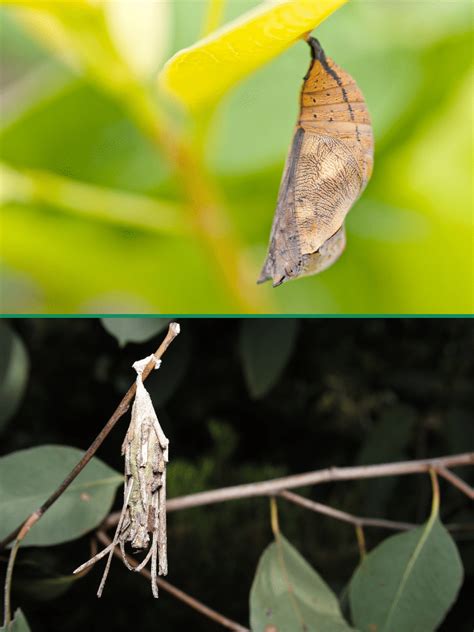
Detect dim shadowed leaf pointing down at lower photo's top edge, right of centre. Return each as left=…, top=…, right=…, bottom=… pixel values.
left=240, top=319, right=298, bottom=398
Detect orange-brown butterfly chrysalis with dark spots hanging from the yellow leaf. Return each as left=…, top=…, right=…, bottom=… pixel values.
left=258, top=37, right=374, bottom=287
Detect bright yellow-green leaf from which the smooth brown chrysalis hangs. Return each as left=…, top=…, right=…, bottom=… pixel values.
left=159, top=0, right=347, bottom=109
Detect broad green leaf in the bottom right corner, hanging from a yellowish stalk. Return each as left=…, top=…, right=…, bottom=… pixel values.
left=349, top=508, right=463, bottom=632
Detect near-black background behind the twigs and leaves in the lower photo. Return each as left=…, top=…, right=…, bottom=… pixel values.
left=0, top=319, right=474, bottom=632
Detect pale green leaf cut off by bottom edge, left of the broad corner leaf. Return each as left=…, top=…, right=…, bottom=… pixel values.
left=250, top=535, right=352, bottom=632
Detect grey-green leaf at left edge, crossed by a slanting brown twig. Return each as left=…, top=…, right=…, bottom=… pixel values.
left=0, top=446, right=123, bottom=546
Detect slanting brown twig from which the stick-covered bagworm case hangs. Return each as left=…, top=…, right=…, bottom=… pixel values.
left=0, top=323, right=179, bottom=549
